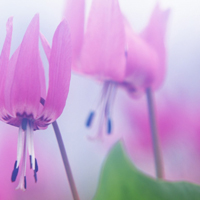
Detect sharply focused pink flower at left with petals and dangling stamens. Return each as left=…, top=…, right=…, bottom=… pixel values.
left=0, top=14, right=71, bottom=190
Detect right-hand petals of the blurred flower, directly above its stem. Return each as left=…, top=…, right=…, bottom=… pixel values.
left=122, top=4, right=170, bottom=95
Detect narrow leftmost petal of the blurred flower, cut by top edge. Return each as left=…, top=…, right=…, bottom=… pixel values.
left=64, top=0, right=85, bottom=71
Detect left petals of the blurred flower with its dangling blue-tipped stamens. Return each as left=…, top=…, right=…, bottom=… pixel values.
left=65, top=0, right=126, bottom=138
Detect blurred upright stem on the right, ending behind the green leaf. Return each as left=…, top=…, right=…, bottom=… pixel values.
left=146, top=88, right=164, bottom=179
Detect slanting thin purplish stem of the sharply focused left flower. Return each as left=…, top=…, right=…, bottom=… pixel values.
left=52, top=121, right=79, bottom=200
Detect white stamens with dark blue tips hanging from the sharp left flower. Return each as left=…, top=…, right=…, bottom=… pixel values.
left=11, top=118, right=38, bottom=191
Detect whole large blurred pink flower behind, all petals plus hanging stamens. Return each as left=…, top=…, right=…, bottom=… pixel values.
left=65, top=0, right=167, bottom=138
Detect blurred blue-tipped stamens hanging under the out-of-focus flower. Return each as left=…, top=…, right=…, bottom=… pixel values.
left=86, top=81, right=117, bottom=136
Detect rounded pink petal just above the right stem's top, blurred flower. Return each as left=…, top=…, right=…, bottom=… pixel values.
left=125, top=19, right=159, bottom=94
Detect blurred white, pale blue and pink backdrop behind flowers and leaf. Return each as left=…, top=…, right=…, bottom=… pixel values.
left=0, top=0, right=200, bottom=200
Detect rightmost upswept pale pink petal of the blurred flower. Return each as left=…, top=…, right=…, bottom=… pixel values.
left=141, top=4, right=170, bottom=87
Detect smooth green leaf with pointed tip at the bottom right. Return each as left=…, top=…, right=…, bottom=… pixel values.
left=93, top=143, right=200, bottom=200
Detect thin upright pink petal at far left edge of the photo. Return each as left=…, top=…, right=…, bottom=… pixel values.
left=0, top=17, right=13, bottom=115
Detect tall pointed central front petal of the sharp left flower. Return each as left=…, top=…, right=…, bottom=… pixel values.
left=11, top=14, right=41, bottom=117
